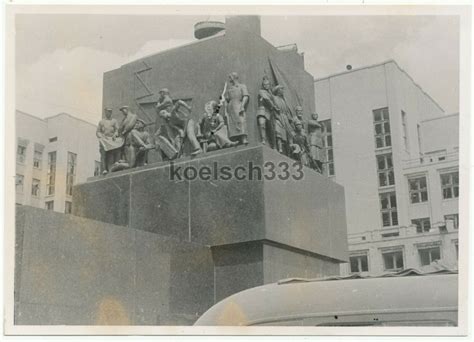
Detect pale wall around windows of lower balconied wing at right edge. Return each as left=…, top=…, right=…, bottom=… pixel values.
left=341, top=153, right=460, bottom=274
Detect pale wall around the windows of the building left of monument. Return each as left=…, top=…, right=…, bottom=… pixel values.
left=15, top=111, right=100, bottom=212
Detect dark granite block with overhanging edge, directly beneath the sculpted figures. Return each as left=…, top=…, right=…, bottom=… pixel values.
left=73, top=146, right=347, bottom=261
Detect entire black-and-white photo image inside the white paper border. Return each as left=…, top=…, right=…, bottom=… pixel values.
left=8, top=6, right=465, bottom=334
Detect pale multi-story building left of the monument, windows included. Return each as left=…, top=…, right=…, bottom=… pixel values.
left=15, top=111, right=100, bottom=213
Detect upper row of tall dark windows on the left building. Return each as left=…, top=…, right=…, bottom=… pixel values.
left=15, top=151, right=77, bottom=197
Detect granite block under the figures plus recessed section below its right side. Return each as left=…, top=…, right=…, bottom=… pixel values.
left=73, top=146, right=347, bottom=300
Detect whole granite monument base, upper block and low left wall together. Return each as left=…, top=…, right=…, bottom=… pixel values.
left=15, top=146, right=347, bottom=325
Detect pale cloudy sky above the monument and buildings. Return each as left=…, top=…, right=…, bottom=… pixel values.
left=16, top=14, right=459, bottom=123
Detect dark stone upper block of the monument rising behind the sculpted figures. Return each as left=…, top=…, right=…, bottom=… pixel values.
left=103, top=16, right=314, bottom=163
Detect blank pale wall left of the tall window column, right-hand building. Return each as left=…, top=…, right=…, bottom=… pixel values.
left=315, top=66, right=388, bottom=233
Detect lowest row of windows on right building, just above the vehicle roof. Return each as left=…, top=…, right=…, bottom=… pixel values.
left=349, top=241, right=459, bottom=273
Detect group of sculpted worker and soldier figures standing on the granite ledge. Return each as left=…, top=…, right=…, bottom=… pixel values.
left=96, top=72, right=324, bottom=174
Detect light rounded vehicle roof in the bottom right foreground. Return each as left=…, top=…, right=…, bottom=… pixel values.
left=195, top=269, right=458, bottom=326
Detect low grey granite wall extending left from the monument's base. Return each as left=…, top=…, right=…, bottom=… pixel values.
left=14, top=207, right=214, bottom=325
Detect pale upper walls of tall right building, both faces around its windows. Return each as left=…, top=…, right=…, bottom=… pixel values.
left=315, top=61, right=444, bottom=233
